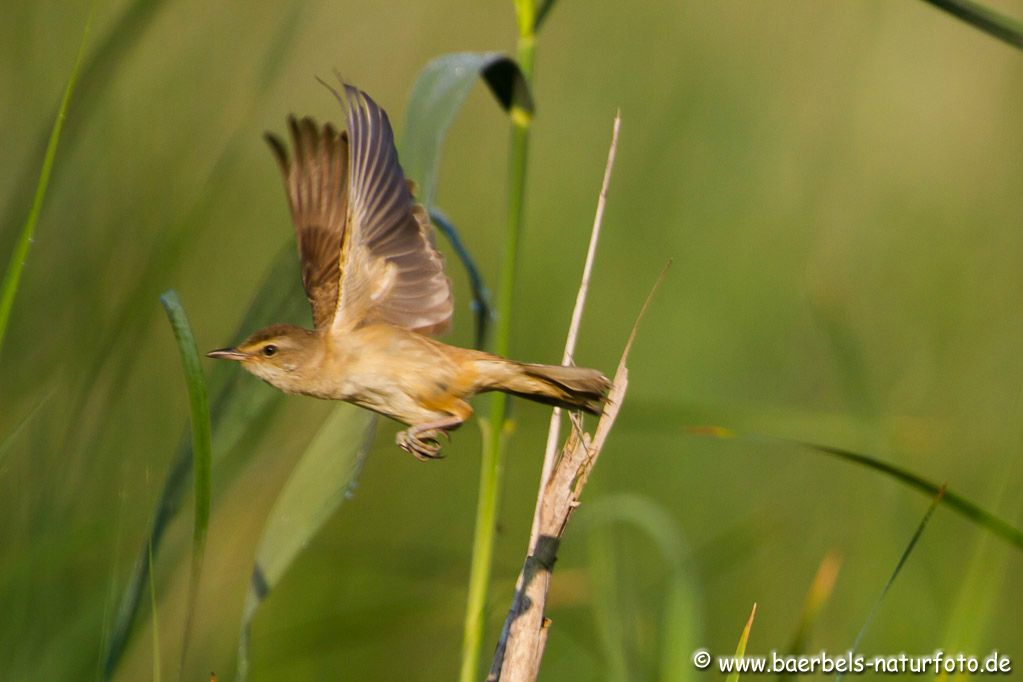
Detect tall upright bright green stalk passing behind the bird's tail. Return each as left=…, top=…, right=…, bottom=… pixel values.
left=458, top=6, right=536, bottom=682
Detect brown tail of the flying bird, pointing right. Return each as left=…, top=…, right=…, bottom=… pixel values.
left=480, top=356, right=611, bottom=415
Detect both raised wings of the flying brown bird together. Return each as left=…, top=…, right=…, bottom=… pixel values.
left=267, top=83, right=452, bottom=333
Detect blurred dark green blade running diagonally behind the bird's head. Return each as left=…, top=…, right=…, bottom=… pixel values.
left=103, top=244, right=308, bottom=678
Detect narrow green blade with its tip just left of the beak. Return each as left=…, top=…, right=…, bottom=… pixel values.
left=150, top=289, right=213, bottom=677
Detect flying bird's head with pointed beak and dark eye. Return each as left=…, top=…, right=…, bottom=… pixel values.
left=206, top=324, right=318, bottom=393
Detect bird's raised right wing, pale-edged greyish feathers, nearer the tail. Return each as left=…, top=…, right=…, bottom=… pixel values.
left=332, top=83, right=452, bottom=333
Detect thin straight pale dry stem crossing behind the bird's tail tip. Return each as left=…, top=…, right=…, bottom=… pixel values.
left=529, top=110, right=622, bottom=551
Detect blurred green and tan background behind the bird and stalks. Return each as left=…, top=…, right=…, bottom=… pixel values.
left=0, top=0, right=1023, bottom=680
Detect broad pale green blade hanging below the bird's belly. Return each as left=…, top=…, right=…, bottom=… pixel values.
left=237, top=404, right=376, bottom=682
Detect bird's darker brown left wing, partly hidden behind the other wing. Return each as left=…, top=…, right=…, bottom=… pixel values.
left=266, top=117, right=348, bottom=329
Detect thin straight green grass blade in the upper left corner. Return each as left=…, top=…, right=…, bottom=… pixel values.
left=0, top=5, right=94, bottom=359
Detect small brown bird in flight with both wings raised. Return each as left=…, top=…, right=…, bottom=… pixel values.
left=207, top=78, right=611, bottom=460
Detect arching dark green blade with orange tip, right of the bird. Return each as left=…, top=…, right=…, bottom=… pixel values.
left=687, top=426, right=1023, bottom=549
